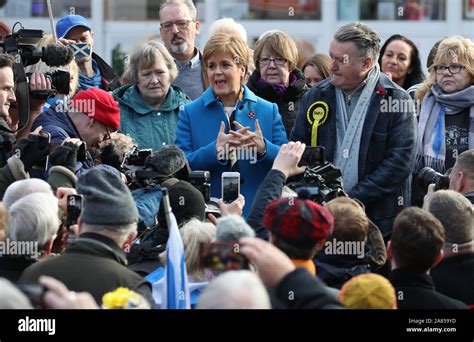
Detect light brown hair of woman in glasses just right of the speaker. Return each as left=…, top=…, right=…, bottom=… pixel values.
left=253, top=30, right=298, bottom=71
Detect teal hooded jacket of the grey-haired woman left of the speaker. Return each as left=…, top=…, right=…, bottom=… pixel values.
left=112, top=84, right=190, bottom=150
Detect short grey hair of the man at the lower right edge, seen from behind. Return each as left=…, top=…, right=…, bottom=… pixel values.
left=425, top=190, right=474, bottom=244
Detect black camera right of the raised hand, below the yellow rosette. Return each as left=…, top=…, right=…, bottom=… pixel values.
left=287, top=146, right=347, bottom=204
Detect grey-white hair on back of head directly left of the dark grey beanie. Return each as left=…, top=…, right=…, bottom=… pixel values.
left=7, top=192, right=61, bottom=250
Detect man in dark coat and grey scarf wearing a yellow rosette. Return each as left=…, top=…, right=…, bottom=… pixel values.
left=290, top=23, right=416, bottom=240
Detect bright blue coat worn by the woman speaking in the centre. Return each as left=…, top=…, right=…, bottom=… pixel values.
left=176, top=86, right=287, bottom=217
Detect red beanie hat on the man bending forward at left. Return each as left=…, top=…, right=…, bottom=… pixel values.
left=71, top=88, right=120, bottom=130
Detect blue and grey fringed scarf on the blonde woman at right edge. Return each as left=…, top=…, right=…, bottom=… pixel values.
left=414, top=84, right=474, bottom=172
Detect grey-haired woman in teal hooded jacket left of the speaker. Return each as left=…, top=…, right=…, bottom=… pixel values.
left=113, top=41, right=189, bottom=150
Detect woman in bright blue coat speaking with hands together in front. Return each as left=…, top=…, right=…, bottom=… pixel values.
left=176, top=33, right=287, bottom=216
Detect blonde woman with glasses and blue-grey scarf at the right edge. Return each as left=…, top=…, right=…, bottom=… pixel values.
left=412, top=36, right=474, bottom=204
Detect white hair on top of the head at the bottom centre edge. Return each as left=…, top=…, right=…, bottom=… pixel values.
left=197, top=270, right=271, bottom=309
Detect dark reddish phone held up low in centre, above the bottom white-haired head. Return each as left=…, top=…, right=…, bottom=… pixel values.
left=199, top=241, right=249, bottom=274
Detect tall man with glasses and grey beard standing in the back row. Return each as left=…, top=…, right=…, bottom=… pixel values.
left=160, top=0, right=208, bottom=100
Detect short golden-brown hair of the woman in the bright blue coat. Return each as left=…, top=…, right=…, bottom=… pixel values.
left=202, top=33, right=250, bottom=77
